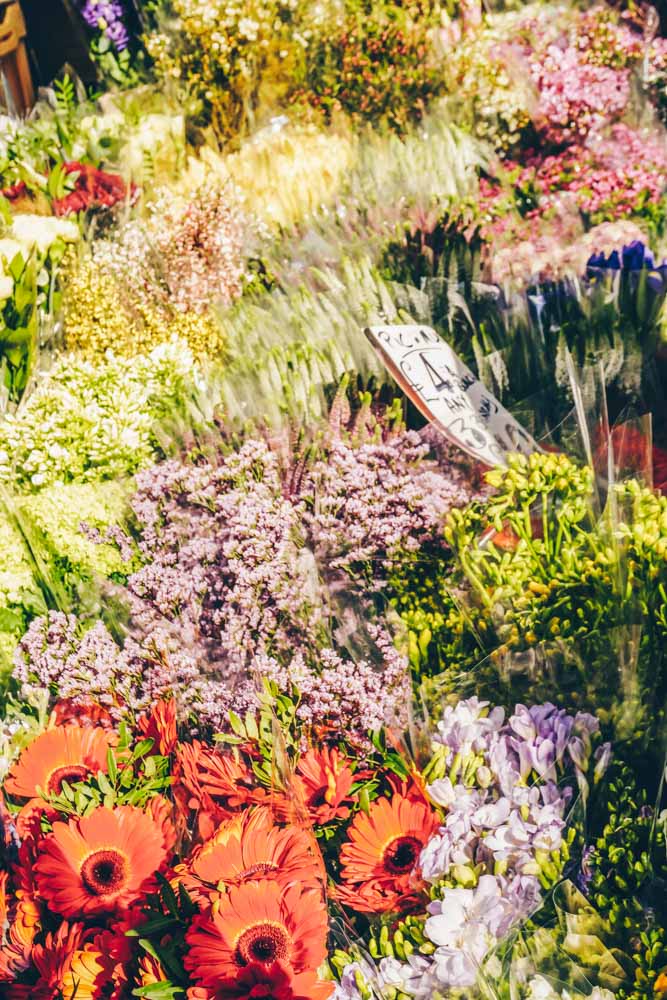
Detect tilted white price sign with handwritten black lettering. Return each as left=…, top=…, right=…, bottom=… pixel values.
left=365, top=326, right=540, bottom=465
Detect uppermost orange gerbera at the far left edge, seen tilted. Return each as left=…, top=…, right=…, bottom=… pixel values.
left=5, top=725, right=113, bottom=799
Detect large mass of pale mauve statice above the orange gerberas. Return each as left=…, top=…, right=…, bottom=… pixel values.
left=15, top=419, right=480, bottom=744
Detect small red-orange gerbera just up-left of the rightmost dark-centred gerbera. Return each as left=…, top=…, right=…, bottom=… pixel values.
left=296, top=748, right=355, bottom=825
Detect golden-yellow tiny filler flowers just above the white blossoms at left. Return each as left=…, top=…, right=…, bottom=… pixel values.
left=63, top=257, right=224, bottom=360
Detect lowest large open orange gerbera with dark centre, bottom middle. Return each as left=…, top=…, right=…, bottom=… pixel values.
left=184, top=882, right=327, bottom=990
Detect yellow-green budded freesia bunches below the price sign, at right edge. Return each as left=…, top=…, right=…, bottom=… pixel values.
left=392, top=454, right=667, bottom=741
